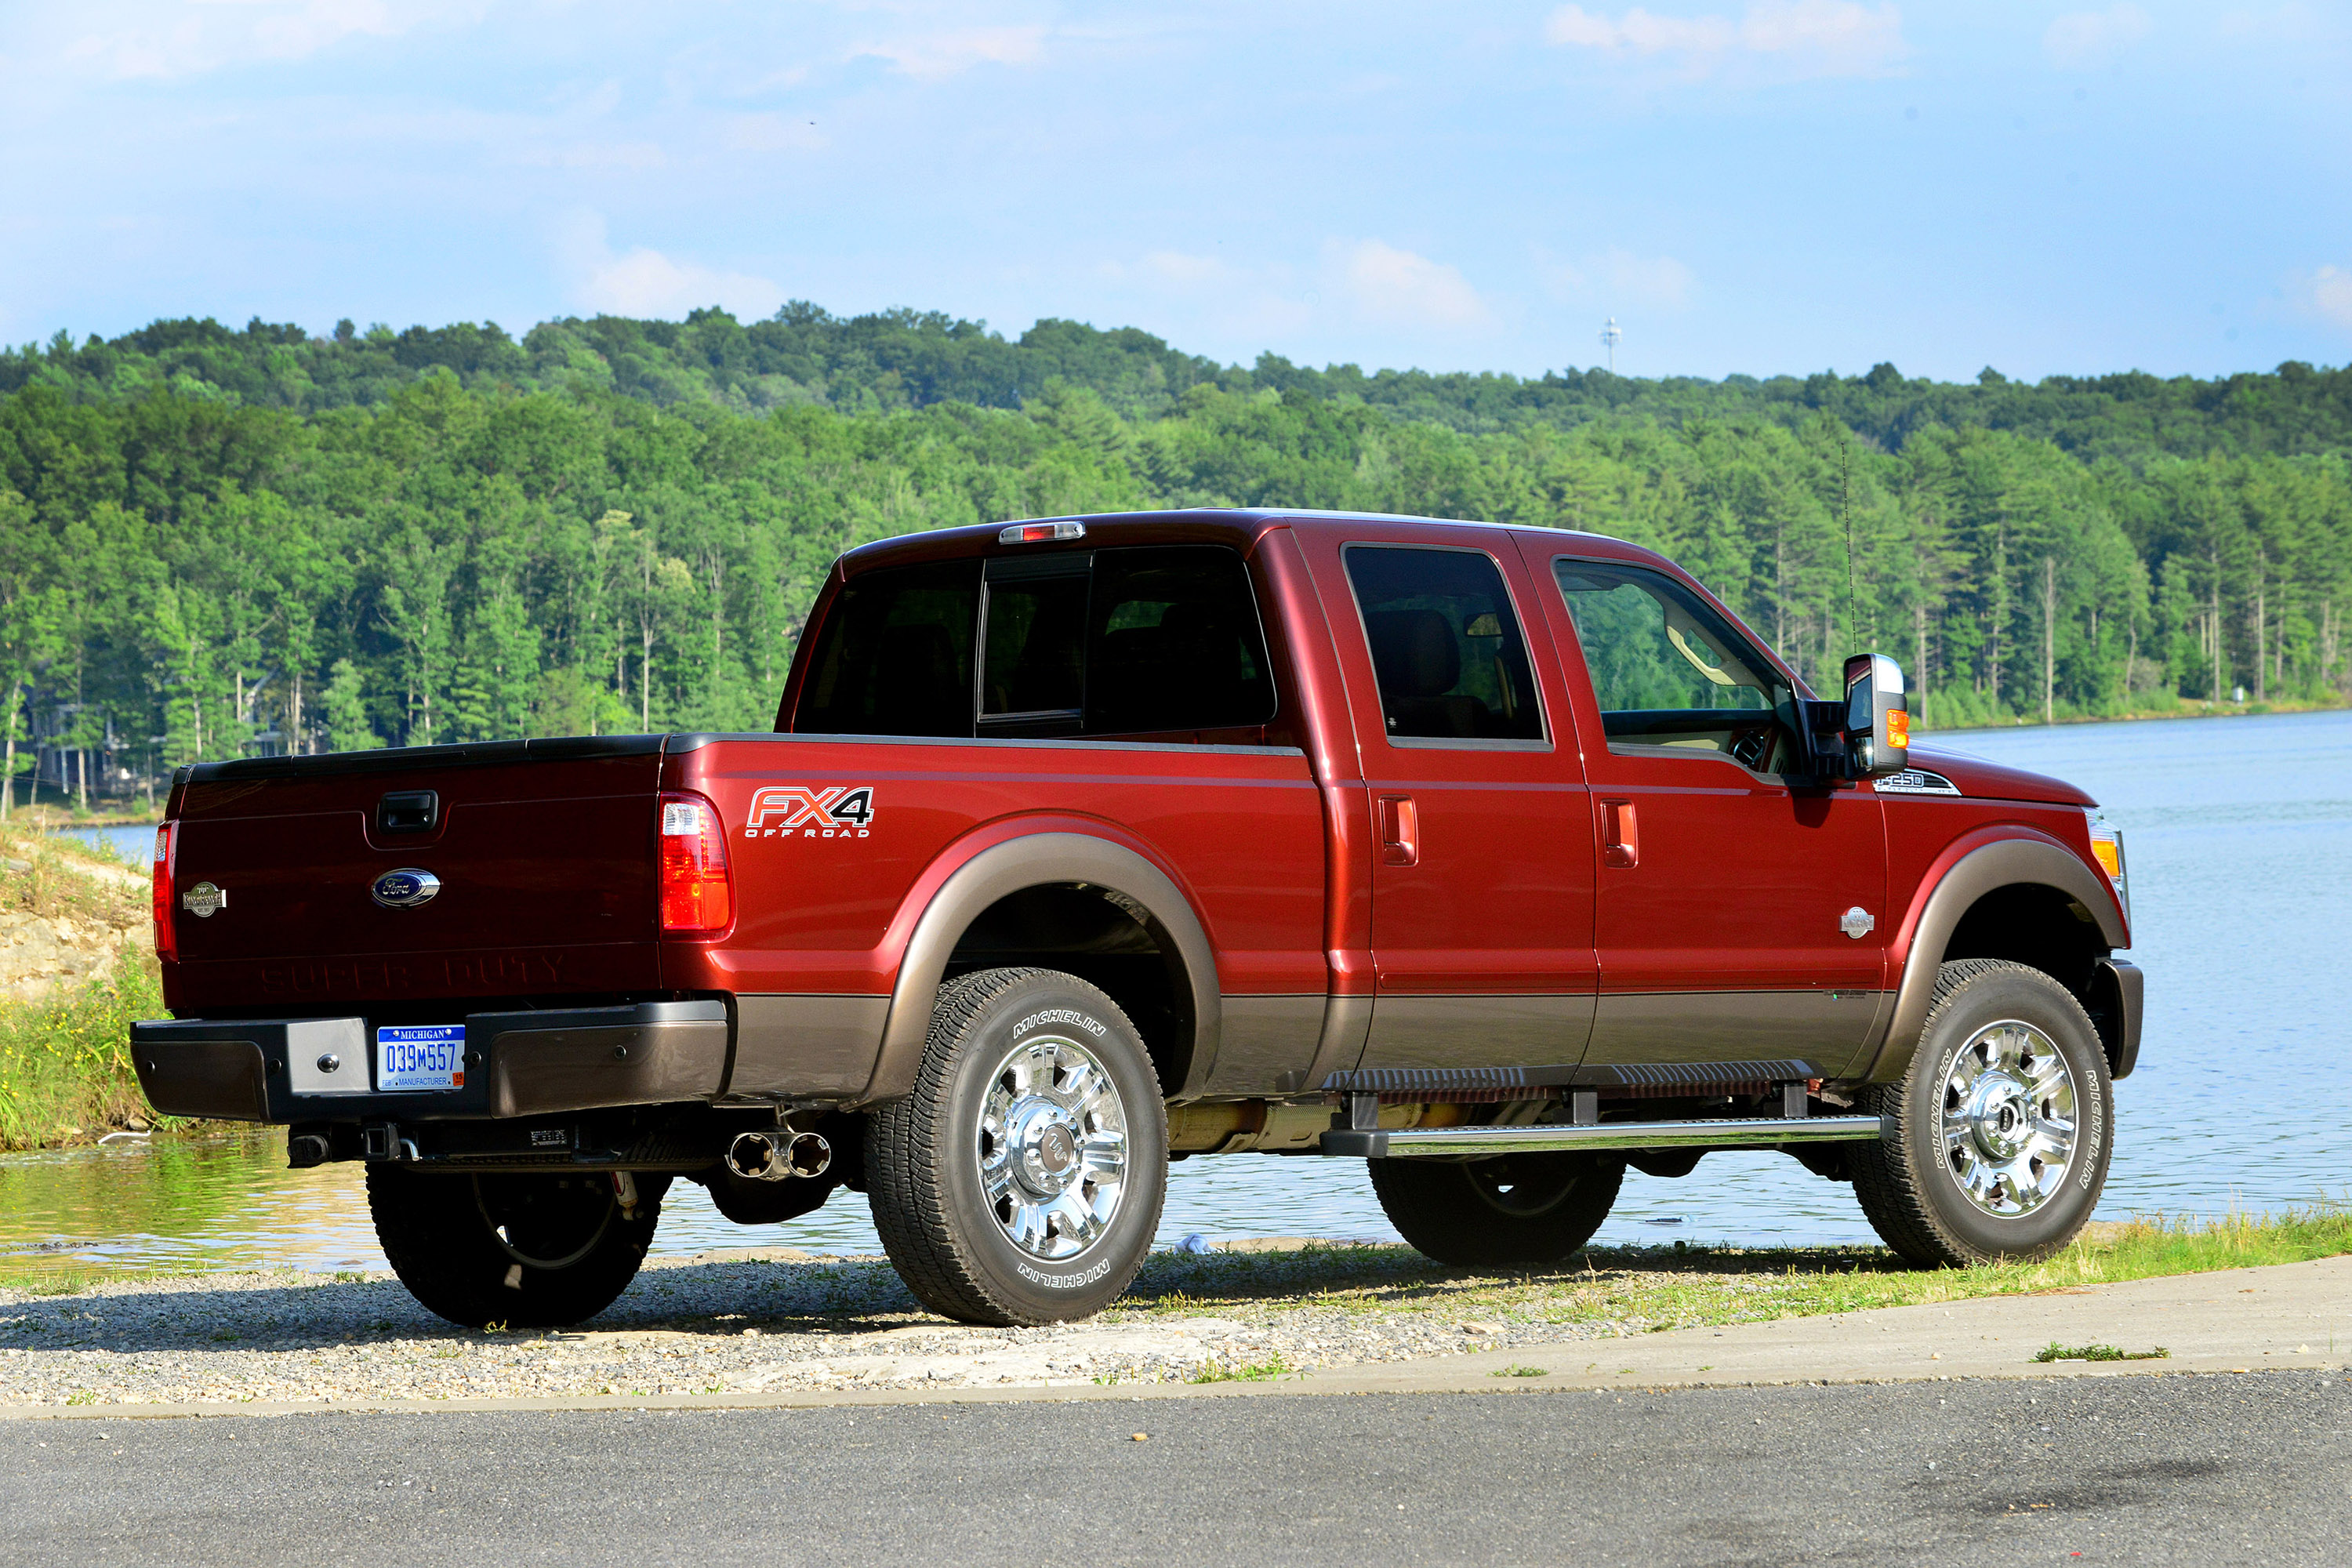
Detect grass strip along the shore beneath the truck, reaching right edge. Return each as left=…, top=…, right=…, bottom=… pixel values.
left=1110, top=1203, right=2352, bottom=1333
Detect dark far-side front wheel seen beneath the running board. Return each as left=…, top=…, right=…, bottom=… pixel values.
left=1371, top=1154, right=1625, bottom=1269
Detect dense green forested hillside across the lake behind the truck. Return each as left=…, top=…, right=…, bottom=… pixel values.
left=0, top=306, right=2352, bottom=804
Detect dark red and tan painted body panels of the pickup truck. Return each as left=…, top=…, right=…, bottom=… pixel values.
left=147, top=513, right=2129, bottom=1098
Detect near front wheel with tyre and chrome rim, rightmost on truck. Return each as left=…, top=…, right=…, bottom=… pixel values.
left=1851, top=959, right=2114, bottom=1267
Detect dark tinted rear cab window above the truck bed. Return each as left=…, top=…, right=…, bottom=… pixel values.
left=790, top=546, right=1277, bottom=743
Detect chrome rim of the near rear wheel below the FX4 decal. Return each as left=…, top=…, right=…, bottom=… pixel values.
left=974, top=1034, right=1127, bottom=1260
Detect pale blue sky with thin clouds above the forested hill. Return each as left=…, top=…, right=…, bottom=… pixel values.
left=0, top=0, right=2352, bottom=379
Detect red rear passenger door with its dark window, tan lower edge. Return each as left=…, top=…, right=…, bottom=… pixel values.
left=1317, top=524, right=1595, bottom=1072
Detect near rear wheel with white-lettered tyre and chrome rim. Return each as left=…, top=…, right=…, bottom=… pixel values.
left=866, top=968, right=1169, bottom=1326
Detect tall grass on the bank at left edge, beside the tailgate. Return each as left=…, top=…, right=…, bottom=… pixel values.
left=0, top=825, right=162, bottom=1149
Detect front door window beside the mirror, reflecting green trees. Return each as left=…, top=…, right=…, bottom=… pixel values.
left=1552, top=560, right=1797, bottom=771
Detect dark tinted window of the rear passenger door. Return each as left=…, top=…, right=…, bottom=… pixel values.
left=1345, top=546, right=1543, bottom=741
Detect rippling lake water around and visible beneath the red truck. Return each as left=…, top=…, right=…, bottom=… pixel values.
left=0, top=713, right=2352, bottom=1276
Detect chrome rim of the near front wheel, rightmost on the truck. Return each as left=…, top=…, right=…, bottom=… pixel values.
left=1943, top=1018, right=2074, bottom=1218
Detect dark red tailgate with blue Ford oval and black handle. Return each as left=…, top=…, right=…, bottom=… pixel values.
left=174, top=736, right=661, bottom=1008
